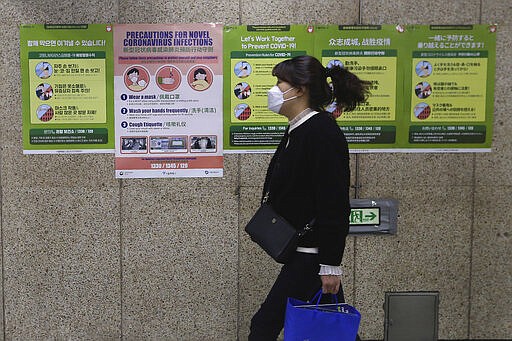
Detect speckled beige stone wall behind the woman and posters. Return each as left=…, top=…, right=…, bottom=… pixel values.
left=0, top=0, right=512, bottom=341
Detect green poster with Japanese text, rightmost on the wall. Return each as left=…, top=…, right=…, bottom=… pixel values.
left=404, top=25, right=496, bottom=151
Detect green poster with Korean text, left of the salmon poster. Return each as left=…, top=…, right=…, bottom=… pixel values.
left=20, top=24, right=114, bottom=154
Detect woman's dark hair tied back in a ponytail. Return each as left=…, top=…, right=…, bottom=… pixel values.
left=272, top=56, right=371, bottom=111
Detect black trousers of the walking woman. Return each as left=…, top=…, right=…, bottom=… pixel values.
left=249, top=252, right=359, bottom=341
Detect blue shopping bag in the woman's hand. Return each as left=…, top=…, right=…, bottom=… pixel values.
left=284, top=290, right=361, bottom=341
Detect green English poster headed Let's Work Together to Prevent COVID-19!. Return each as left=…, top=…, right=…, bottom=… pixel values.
left=224, top=25, right=313, bottom=152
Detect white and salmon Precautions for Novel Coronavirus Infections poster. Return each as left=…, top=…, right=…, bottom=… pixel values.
left=114, top=24, right=223, bottom=178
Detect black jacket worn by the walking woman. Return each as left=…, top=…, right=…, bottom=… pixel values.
left=264, top=112, right=350, bottom=265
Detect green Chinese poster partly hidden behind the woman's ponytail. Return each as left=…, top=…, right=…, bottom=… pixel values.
left=315, top=25, right=404, bottom=151
